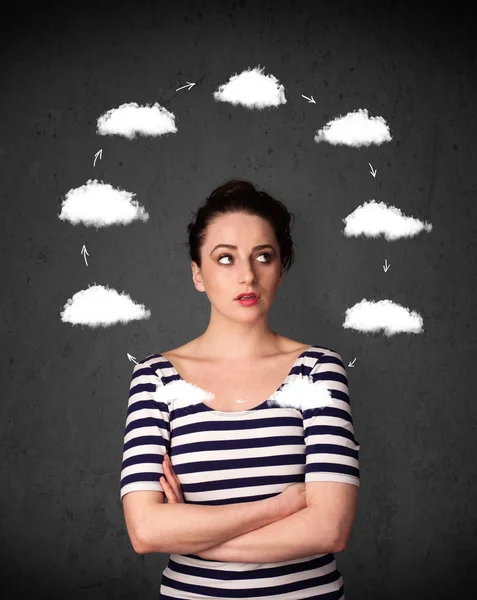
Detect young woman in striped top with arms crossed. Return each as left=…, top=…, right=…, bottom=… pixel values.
left=121, top=180, right=360, bottom=600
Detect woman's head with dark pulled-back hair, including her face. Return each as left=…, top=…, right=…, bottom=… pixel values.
left=188, top=180, right=294, bottom=320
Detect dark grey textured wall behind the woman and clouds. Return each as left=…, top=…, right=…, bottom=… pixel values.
left=0, top=1, right=477, bottom=600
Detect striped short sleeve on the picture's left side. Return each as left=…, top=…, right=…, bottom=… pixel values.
left=120, top=363, right=170, bottom=502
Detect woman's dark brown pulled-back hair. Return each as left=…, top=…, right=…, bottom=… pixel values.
left=187, top=179, right=295, bottom=271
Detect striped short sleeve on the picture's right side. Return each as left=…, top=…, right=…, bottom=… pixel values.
left=303, top=349, right=360, bottom=487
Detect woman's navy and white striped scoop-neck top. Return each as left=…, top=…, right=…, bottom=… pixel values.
left=120, top=346, right=360, bottom=600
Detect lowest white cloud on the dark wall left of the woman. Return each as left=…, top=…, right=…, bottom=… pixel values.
left=61, top=285, right=151, bottom=327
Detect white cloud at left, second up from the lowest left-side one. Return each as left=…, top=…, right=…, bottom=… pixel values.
left=58, top=179, right=149, bottom=228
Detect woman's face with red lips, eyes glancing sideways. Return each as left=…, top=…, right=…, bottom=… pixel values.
left=192, top=213, right=283, bottom=320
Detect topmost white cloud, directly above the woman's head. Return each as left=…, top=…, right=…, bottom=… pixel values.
left=214, top=67, right=287, bottom=109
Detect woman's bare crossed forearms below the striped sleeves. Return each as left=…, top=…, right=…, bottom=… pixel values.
left=135, top=481, right=359, bottom=563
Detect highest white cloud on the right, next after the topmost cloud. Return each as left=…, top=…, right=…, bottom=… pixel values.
left=315, top=109, right=392, bottom=148
